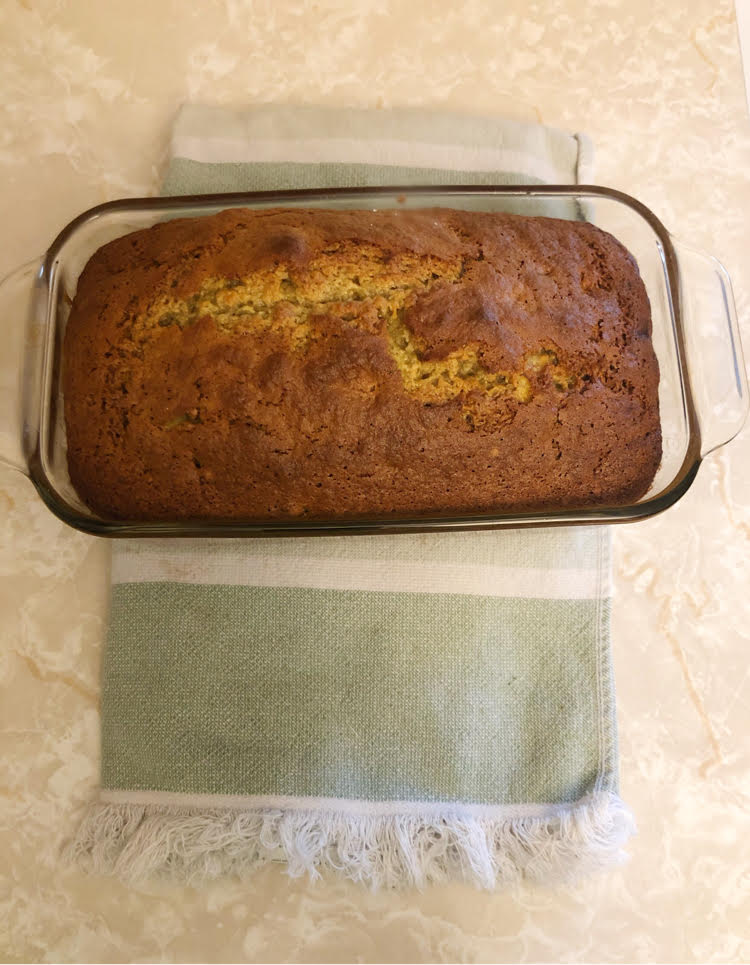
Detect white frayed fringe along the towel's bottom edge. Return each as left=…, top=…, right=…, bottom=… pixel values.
left=65, top=792, right=635, bottom=890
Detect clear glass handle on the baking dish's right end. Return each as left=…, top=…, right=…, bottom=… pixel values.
left=673, top=239, right=748, bottom=456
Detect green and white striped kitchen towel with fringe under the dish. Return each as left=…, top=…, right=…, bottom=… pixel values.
left=68, top=105, right=633, bottom=889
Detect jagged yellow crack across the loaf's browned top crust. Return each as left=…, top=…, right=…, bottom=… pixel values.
left=129, top=248, right=576, bottom=406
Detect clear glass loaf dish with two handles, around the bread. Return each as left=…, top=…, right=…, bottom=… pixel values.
left=0, top=185, right=748, bottom=537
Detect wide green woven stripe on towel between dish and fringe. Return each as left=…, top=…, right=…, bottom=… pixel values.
left=102, top=583, right=614, bottom=804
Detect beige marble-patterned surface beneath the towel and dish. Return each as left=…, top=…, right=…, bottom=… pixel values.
left=0, top=0, right=750, bottom=962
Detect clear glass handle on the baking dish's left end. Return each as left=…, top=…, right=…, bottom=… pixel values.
left=0, top=260, right=39, bottom=475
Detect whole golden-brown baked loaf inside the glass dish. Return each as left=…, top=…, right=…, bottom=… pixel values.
left=64, top=209, right=661, bottom=520
